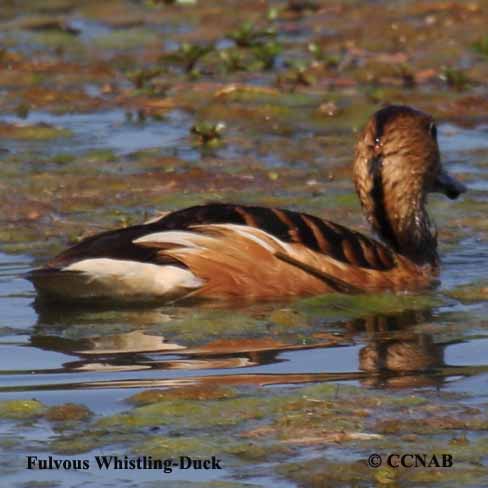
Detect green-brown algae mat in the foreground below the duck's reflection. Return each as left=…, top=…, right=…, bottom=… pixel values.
left=0, top=384, right=476, bottom=486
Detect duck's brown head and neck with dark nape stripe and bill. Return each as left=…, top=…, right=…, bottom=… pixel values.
left=354, top=105, right=466, bottom=263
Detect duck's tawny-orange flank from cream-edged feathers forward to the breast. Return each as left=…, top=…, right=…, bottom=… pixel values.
left=135, top=224, right=425, bottom=299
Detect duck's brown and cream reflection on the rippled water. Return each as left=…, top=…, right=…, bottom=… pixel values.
left=31, top=305, right=459, bottom=388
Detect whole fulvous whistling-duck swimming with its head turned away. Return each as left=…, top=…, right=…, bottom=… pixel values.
left=28, top=105, right=466, bottom=302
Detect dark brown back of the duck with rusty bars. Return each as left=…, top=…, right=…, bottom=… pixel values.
left=50, top=203, right=394, bottom=270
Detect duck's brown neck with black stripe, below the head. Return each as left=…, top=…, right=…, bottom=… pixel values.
left=363, top=158, right=439, bottom=267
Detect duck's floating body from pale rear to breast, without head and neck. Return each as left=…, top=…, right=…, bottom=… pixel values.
left=31, top=204, right=428, bottom=299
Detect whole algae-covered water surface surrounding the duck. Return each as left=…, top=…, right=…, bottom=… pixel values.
left=0, top=0, right=488, bottom=488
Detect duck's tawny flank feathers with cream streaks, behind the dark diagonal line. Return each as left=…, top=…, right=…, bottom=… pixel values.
left=135, top=224, right=338, bottom=299
